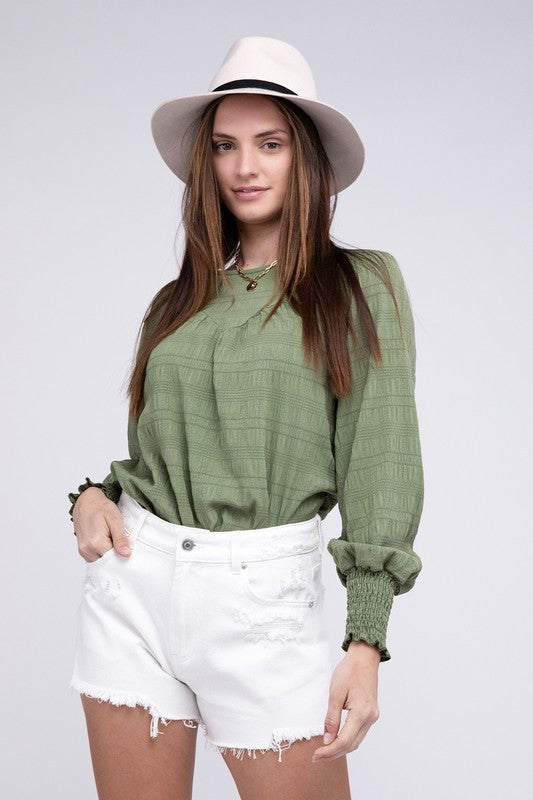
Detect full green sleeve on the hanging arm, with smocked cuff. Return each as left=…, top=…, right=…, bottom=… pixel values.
left=327, top=253, right=424, bottom=661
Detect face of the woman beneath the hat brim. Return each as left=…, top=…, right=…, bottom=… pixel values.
left=213, top=94, right=292, bottom=231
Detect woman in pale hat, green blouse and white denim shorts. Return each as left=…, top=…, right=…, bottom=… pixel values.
left=69, top=37, right=423, bottom=800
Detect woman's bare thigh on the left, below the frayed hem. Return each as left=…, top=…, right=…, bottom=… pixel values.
left=81, top=695, right=198, bottom=800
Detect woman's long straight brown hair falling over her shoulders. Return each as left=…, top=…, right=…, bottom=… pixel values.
left=128, top=97, right=401, bottom=419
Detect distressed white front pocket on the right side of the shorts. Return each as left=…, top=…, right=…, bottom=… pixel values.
left=241, top=546, right=322, bottom=607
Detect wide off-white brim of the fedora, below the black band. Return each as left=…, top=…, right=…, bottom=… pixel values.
left=151, top=88, right=365, bottom=194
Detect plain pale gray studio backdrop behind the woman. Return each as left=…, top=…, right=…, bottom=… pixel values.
left=0, top=0, right=533, bottom=800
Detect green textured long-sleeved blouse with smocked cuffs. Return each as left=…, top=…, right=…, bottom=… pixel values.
left=69, top=251, right=424, bottom=661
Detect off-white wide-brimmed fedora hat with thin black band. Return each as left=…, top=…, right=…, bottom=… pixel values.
left=151, top=36, right=365, bottom=194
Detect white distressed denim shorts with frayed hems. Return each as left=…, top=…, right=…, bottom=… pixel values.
left=70, top=492, right=332, bottom=761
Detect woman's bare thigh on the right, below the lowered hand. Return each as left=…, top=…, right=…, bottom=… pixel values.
left=219, top=736, right=351, bottom=800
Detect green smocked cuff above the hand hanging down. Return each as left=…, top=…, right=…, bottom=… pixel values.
left=341, top=567, right=396, bottom=661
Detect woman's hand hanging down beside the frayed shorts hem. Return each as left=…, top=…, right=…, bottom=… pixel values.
left=311, top=641, right=381, bottom=763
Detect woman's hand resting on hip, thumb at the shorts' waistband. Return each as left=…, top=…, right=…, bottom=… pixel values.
left=72, top=486, right=131, bottom=561
